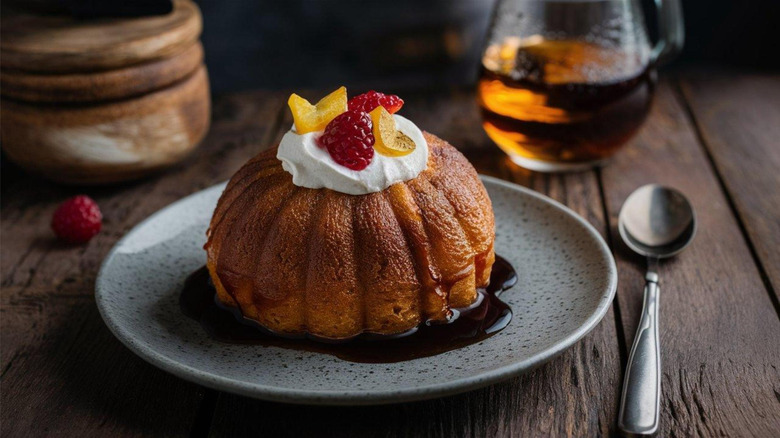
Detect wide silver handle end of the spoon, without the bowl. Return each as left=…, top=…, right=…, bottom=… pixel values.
left=618, top=271, right=661, bottom=434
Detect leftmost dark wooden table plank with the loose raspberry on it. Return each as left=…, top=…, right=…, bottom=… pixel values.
left=0, top=93, right=283, bottom=436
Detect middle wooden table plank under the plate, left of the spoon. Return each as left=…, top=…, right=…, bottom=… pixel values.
left=206, top=92, right=621, bottom=437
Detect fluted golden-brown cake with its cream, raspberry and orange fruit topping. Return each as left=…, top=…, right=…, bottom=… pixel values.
left=205, top=87, right=495, bottom=340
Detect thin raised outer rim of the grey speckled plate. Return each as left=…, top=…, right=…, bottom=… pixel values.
left=95, top=175, right=617, bottom=405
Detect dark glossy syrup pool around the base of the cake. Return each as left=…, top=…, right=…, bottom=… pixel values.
left=179, top=256, right=517, bottom=363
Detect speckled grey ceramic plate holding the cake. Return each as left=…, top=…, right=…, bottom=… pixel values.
left=96, top=177, right=617, bottom=405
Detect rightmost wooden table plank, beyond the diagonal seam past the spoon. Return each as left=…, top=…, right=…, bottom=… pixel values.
left=680, top=71, right=780, bottom=297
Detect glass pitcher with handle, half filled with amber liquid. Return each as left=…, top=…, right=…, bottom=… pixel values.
left=477, top=0, right=684, bottom=172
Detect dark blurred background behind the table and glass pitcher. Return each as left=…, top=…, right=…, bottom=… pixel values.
left=190, top=0, right=780, bottom=92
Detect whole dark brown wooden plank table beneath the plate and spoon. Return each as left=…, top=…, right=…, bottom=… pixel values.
left=0, top=70, right=780, bottom=437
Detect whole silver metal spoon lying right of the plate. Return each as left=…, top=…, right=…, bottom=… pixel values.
left=618, top=184, right=696, bottom=434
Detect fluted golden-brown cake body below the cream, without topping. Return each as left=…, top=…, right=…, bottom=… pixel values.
left=205, top=132, right=495, bottom=339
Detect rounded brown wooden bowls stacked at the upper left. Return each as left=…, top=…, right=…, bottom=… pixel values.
left=0, top=0, right=211, bottom=184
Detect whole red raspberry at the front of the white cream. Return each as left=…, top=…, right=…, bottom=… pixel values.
left=317, top=110, right=374, bottom=170
